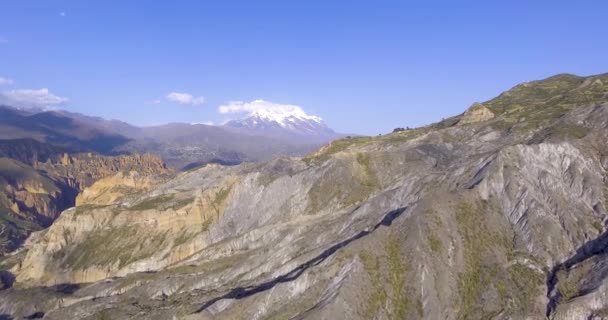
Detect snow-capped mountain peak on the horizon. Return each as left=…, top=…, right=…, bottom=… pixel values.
left=225, top=107, right=340, bottom=142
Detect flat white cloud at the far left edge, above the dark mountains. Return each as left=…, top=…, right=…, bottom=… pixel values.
left=0, top=88, right=68, bottom=108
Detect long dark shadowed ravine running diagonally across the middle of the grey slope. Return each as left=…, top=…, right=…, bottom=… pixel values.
left=195, top=207, right=407, bottom=313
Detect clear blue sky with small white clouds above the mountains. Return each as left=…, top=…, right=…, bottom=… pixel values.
left=0, top=0, right=608, bottom=135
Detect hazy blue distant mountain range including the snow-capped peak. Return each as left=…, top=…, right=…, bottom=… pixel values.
left=0, top=106, right=342, bottom=169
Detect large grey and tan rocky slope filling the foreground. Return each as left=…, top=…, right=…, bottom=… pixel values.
left=0, top=75, right=608, bottom=319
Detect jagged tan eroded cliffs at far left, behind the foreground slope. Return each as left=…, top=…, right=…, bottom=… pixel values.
left=0, top=153, right=173, bottom=255
